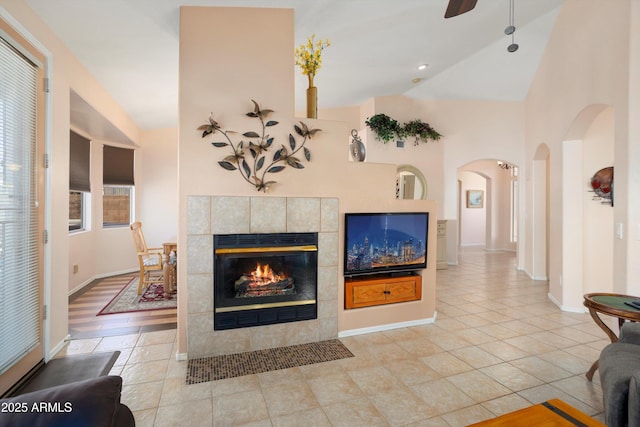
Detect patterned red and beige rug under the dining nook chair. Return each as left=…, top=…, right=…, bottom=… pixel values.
left=97, top=277, right=178, bottom=316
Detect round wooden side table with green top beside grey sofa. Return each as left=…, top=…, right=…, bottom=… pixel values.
left=584, top=293, right=640, bottom=381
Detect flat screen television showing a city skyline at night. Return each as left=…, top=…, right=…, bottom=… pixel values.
left=344, top=212, right=429, bottom=277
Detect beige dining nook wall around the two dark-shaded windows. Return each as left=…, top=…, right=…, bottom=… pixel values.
left=69, top=129, right=178, bottom=293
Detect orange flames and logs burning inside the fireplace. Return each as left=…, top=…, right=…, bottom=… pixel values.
left=234, top=263, right=296, bottom=298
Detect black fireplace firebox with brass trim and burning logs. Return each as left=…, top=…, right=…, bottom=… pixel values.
left=213, top=233, right=318, bottom=330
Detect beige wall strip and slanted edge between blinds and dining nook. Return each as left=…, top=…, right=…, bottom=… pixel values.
left=0, top=0, right=139, bottom=358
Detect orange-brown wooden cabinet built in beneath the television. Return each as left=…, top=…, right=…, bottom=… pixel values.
left=344, top=274, right=422, bottom=309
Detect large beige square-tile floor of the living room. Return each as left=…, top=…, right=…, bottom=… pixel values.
left=57, top=249, right=608, bottom=427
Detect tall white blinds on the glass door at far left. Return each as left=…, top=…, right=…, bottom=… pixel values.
left=0, top=38, right=40, bottom=373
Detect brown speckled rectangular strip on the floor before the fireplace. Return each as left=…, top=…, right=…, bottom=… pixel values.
left=187, top=339, right=353, bottom=384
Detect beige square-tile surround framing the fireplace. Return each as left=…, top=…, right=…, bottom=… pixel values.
left=185, top=196, right=339, bottom=359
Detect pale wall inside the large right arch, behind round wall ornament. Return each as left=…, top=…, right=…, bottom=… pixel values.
left=548, top=104, right=615, bottom=311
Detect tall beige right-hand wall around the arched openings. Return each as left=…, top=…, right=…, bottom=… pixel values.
left=523, top=0, right=640, bottom=310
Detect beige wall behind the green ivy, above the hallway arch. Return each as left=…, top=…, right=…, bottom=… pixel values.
left=350, top=96, right=524, bottom=265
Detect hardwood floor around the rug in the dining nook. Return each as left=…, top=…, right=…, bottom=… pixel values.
left=69, top=273, right=177, bottom=339
